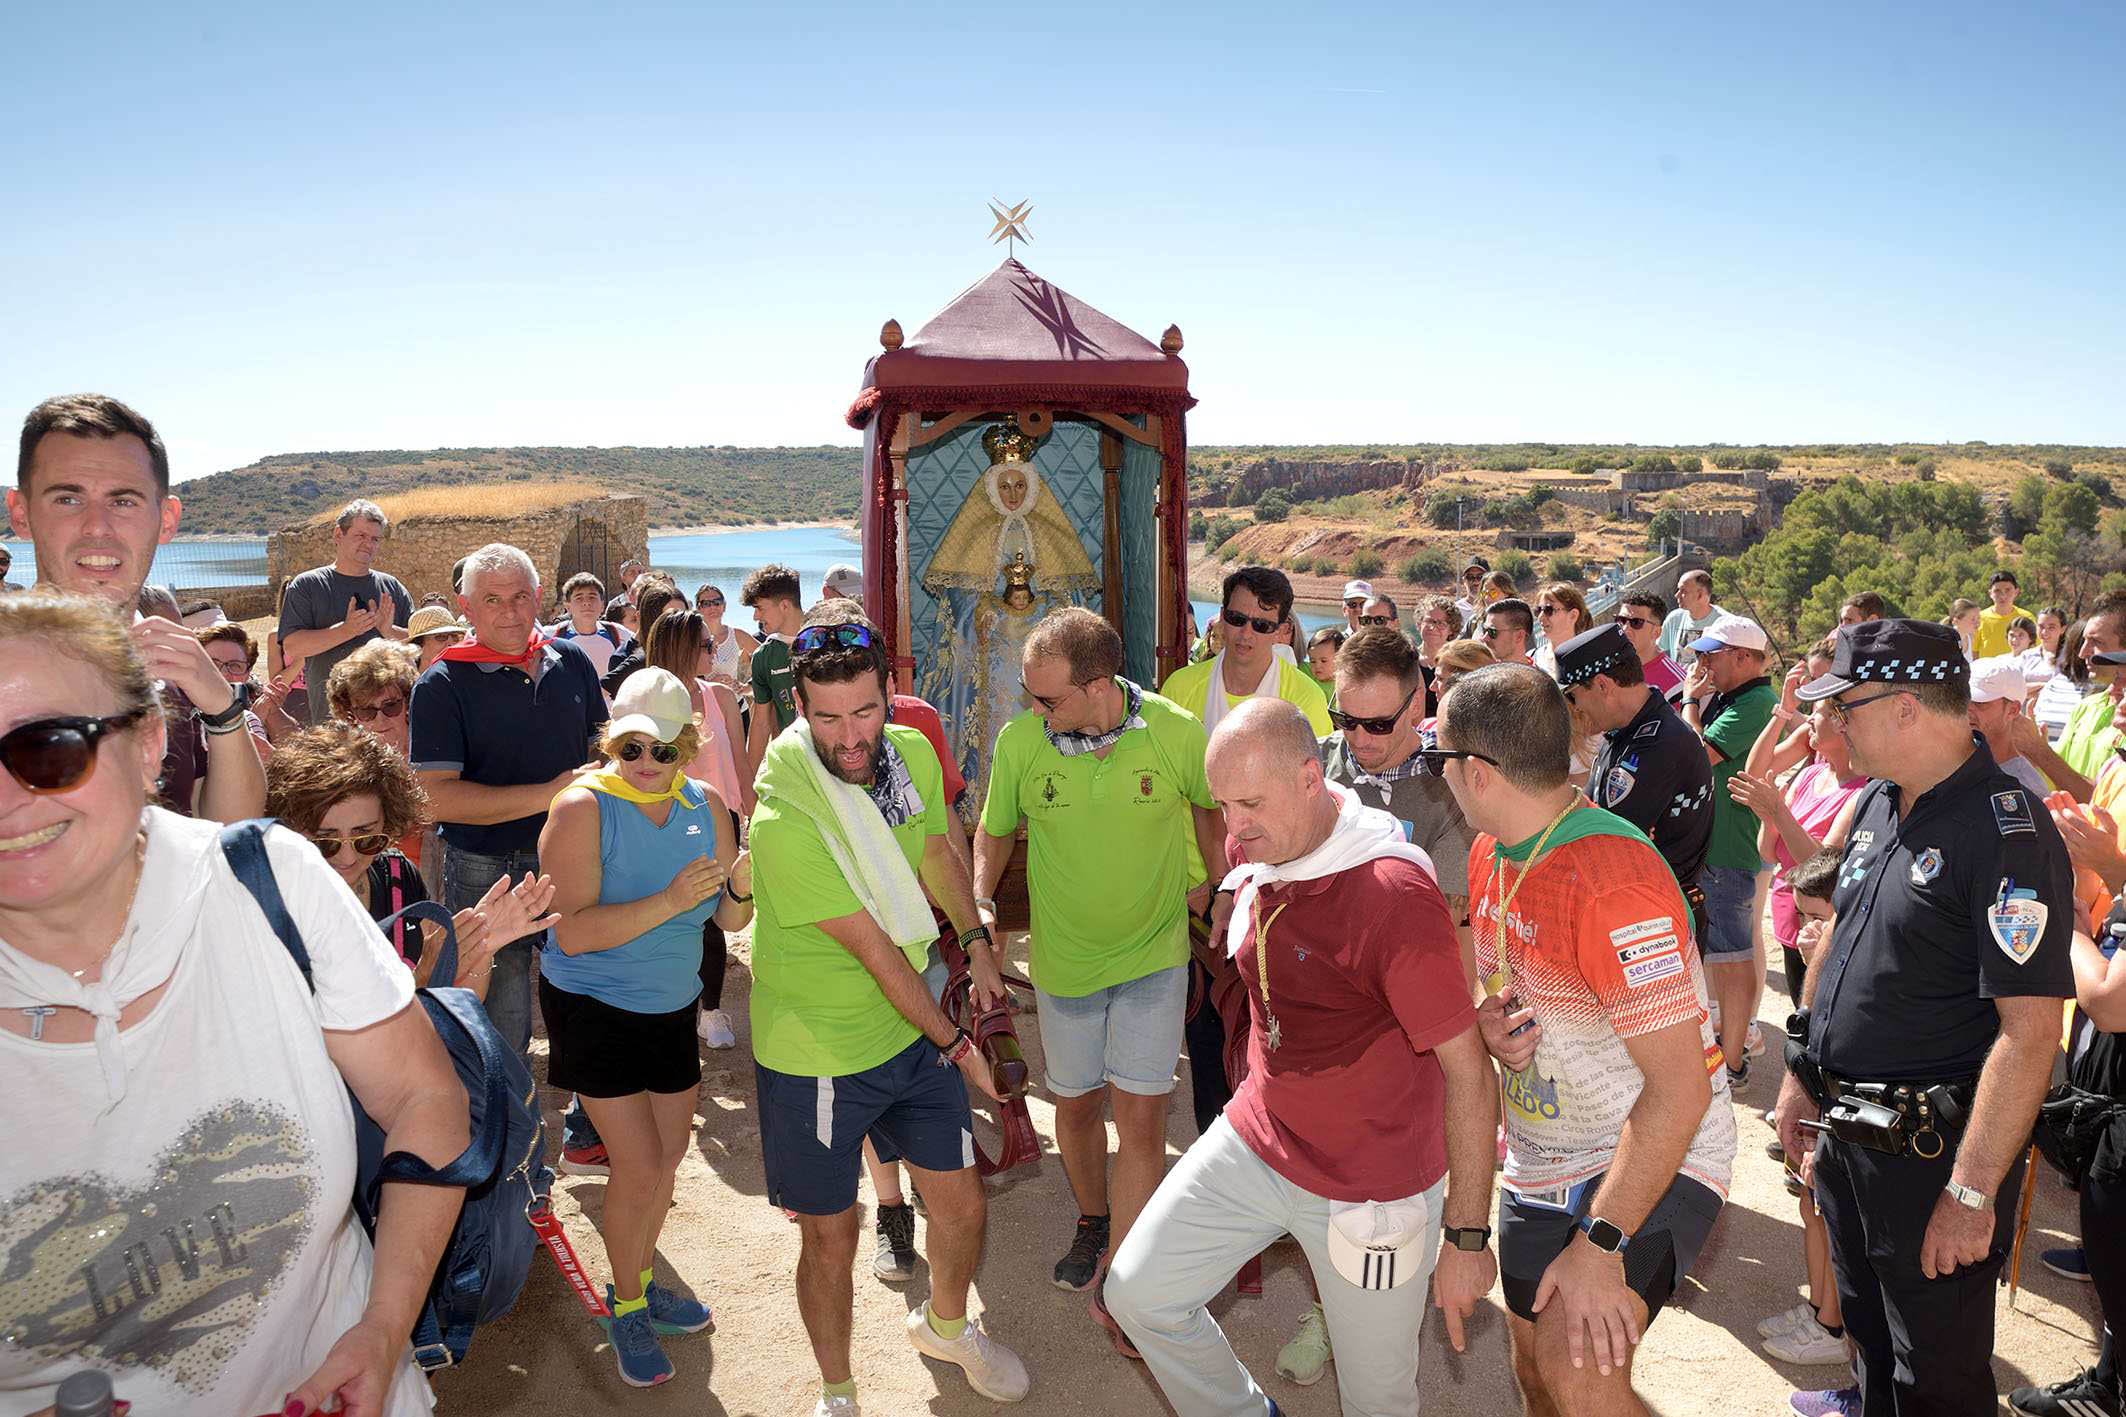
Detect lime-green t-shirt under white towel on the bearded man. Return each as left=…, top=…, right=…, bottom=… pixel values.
left=750, top=724, right=946, bottom=1077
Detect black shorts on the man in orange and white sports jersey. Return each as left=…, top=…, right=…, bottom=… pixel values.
left=1499, top=1175, right=1724, bottom=1324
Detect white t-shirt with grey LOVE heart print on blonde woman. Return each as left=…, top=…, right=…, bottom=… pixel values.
left=0, top=807, right=434, bottom=1417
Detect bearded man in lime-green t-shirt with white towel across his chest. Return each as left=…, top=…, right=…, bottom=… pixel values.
left=750, top=599, right=1029, bottom=1417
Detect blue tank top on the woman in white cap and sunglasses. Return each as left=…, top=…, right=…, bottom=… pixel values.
left=538, top=780, right=723, bottom=1013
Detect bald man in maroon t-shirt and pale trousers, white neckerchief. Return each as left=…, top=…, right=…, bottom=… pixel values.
left=1108, top=699, right=1499, bottom=1417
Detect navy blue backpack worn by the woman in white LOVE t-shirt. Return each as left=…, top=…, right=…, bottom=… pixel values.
left=221, top=822, right=553, bottom=1372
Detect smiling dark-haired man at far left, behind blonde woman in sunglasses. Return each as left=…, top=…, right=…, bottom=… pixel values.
left=6, top=393, right=264, bottom=822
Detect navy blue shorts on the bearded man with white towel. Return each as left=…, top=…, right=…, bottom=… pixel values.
left=753, top=1039, right=974, bottom=1215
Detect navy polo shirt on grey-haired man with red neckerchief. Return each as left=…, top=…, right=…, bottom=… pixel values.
left=408, top=639, right=606, bottom=856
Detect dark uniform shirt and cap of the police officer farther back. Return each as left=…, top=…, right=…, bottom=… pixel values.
left=1558, top=625, right=1714, bottom=941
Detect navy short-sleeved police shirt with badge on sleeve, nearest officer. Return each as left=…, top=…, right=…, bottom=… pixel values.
left=1809, top=744, right=2075, bottom=1083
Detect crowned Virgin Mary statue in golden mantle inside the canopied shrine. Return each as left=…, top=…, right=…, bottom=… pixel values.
left=923, top=419, right=1099, bottom=809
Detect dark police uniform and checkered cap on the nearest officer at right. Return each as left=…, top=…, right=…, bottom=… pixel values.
left=1788, top=620, right=2075, bottom=1417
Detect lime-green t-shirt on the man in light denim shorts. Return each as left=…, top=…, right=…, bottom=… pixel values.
left=982, top=693, right=1216, bottom=998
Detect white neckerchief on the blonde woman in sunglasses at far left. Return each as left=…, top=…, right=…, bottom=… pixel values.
left=0, top=807, right=210, bottom=1111
